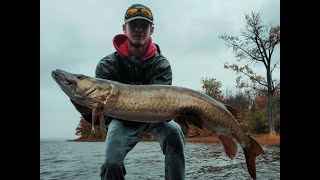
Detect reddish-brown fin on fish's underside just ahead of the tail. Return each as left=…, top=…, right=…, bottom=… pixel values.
left=218, top=135, right=238, bottom=160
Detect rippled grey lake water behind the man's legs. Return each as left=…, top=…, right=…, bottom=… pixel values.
left=40, top=140, right=280, bottom=180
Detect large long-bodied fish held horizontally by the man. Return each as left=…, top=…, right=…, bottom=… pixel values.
left=51, top=69, right=264, bottom=179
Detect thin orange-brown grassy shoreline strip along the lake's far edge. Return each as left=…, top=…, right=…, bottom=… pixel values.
left=67, top=134, right=280, bottom=145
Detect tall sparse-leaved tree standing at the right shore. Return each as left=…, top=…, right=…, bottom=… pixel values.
left=219, top=12, right=280, bottom=134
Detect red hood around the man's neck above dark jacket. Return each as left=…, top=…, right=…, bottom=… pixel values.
left=113, top=34, right=157, bottom=60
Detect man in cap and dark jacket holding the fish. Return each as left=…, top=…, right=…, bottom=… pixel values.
left=73, top=4, right=185, bottom=180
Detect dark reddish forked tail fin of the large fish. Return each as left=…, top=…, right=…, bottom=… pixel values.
left=243, top=136, right=265, bottom=180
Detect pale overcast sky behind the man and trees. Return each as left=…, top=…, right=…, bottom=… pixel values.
left=40, top=0, right=280, bottom=139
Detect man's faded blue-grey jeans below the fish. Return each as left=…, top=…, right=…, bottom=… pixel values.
left=100, top=119, right=185, bottom=180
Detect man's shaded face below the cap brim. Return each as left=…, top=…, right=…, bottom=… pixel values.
left=123, top=19, right=153, bottom=47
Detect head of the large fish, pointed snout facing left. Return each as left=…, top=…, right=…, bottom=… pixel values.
left=51, top=69, right=113, bottom=109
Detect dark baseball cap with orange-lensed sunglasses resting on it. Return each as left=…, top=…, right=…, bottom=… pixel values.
left=124, top=4, right=153, bottom=24
